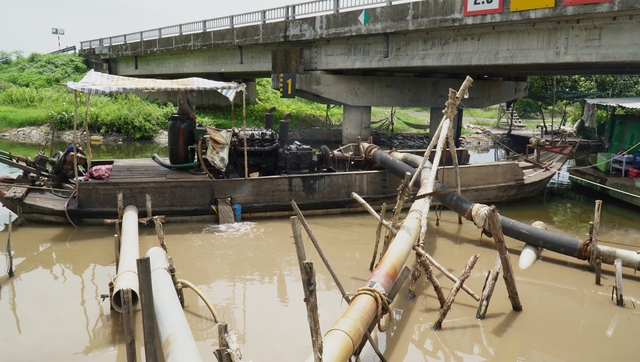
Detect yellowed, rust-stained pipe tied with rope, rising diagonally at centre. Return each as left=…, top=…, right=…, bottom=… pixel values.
left=307, top=156, right=429, bottom=362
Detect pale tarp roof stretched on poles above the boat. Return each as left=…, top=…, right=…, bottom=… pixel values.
left=65, top=70, right=245, bottom=102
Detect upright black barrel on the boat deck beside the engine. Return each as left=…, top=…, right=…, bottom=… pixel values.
left=168, top=114, right=196, bottom=165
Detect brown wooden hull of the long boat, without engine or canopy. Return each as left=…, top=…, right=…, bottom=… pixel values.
left=0, top=143, right=571, bottom=224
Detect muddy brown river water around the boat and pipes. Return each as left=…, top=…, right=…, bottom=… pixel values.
left=0, top=140, right=640, bottom=362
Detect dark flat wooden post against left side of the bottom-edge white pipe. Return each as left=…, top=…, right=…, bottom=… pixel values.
left=136, top=257, right=158, bottom=362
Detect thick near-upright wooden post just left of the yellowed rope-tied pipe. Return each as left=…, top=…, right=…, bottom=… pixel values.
left=289, top=216, right=322, bottom=362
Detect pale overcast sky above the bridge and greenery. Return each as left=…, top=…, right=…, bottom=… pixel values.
left=0, top=0, right=292, bottom=56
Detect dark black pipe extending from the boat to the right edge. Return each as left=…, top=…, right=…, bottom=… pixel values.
left=378, top=150, right=640, bottom=270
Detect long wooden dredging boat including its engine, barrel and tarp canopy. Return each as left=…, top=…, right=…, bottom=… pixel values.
left=0, top=71, right=570, bottom=223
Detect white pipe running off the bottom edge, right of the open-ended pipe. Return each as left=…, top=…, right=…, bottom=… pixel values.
left=147, top=246, right=202, bottom=362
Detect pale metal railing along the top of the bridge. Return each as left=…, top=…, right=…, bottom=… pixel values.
left=80, top=0, right=422, bottom=49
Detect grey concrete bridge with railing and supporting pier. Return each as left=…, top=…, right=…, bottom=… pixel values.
left=80, top=0, right=640, bottom=142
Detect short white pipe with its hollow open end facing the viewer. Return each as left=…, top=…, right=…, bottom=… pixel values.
left=111, top=205, right=140, bottom=313
